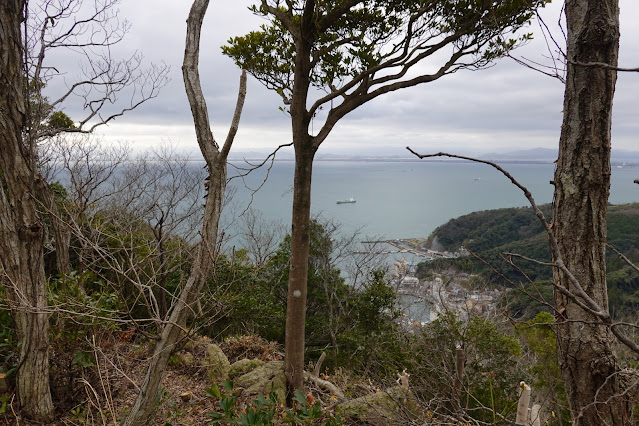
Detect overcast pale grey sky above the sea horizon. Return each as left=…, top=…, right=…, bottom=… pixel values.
left=42, top=0, right=639, bottom=156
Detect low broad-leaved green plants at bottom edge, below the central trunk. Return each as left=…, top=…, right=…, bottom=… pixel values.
left=206, top=380, right=343, bottom=426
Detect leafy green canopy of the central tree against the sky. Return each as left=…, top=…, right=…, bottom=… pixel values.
left=222, top=0, right=550, bottom=112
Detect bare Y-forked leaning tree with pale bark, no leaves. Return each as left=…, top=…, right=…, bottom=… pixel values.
left=123, top=0, right=246, bottom=425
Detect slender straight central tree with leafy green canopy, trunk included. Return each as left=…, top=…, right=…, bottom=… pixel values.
left=223, top=0, right=546, bottom=390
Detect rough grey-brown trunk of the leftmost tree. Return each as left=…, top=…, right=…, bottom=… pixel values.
left=0, top=0, right=54, bottom=422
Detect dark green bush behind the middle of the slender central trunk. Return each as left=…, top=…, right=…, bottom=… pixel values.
left=211, top=221, right=351, bottom=347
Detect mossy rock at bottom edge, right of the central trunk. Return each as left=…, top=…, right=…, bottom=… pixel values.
left=337, top=386, right=421, bottom=425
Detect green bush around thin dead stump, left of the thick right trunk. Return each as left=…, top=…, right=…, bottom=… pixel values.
left=409, top=312, right=528, bottom=422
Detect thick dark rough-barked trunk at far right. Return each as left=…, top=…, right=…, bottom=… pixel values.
left=553, top=0, right=632, bottom=425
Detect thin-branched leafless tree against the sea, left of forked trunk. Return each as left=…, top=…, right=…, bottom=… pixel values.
left=48, top=140, right=206, bottom=323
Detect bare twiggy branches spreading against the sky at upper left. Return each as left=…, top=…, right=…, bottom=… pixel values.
left=23, top=0, right=169, bottom=144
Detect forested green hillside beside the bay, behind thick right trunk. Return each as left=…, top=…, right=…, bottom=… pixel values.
left=419, top=203, right=639, bottom=315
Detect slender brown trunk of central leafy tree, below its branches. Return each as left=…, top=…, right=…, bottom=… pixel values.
left=284, top=143, right=315, bottom=395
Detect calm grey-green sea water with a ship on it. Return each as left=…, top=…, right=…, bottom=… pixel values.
left=223, top=161, right=639, bottom=239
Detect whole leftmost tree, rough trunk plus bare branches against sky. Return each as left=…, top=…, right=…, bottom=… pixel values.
left=0, top=0, right=168, bottom=422
